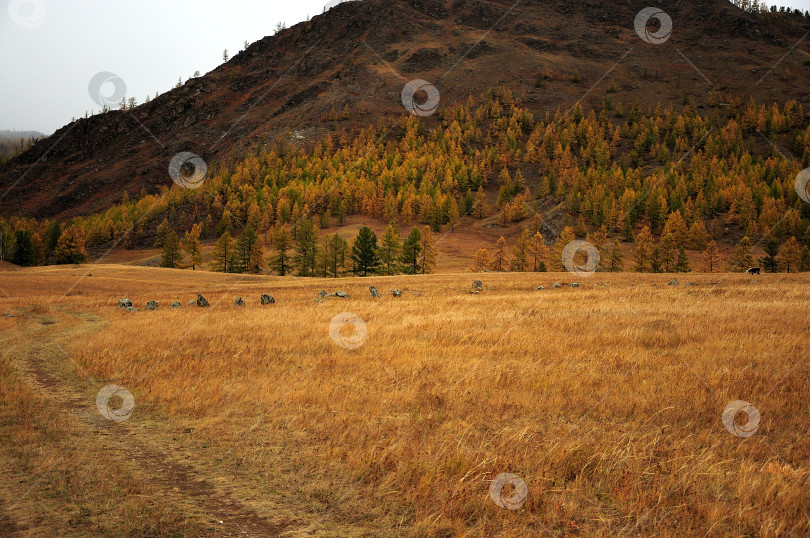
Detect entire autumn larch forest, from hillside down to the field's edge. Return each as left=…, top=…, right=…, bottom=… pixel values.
left=0, top=87, right=810, bottom=277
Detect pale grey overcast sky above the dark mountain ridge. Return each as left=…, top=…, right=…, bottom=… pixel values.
left=0, top=0, right=810, bottom=134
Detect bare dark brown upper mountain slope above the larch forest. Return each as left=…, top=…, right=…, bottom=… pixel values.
left=0, top=0, right=810, bottom=218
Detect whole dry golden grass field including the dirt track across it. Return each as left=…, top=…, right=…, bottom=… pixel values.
left=0, top=265, right=810, bottom=536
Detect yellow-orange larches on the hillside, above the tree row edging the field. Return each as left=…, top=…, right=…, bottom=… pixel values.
left=0, top=87, right=810, bottom=270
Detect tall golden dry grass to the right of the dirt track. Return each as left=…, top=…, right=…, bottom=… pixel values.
left=0, top=267, right=810, bottom=536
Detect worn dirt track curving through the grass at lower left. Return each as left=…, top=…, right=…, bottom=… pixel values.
left=0, top=310, right=290, bottom=536
